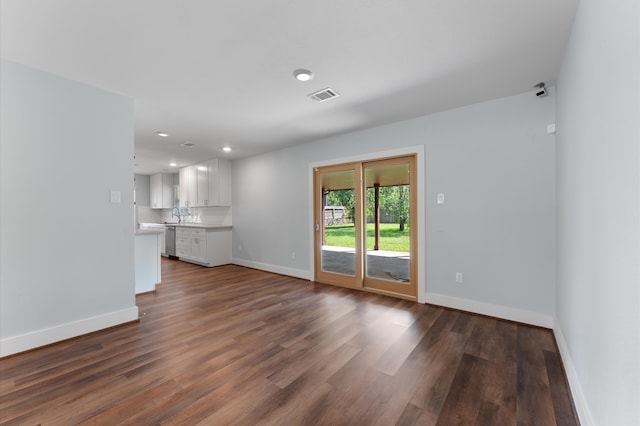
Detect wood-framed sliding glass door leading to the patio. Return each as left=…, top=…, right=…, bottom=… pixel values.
left=314, top=156, right=417, bottom=300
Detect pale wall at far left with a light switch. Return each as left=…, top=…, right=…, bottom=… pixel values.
left=0, top=60, right=137, bottom=356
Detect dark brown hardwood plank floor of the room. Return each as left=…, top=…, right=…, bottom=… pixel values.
left=0, top=259, right=578, bottom=426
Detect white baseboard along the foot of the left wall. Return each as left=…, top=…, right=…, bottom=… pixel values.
left=0, top=306, right=138, bottom=357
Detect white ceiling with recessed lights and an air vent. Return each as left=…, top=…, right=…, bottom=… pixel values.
left=1, top=0, right=577, bottom=174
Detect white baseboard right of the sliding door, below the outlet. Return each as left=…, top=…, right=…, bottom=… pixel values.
left=427, top=293, right=553, bottom=328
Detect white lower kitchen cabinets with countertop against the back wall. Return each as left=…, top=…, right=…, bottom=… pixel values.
left=176, top=226, right=231, bottom=266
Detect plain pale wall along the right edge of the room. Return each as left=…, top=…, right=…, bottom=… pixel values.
left=555, top=0, right=640, bottom=426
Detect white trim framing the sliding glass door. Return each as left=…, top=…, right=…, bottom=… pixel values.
left=308, top=145, right=427, bottom=303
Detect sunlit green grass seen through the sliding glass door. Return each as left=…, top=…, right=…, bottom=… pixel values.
left=325, top=223, right=411, bottom=252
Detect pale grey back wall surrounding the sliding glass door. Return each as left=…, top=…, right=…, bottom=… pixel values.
left=232, top=90, right=555, bottom=327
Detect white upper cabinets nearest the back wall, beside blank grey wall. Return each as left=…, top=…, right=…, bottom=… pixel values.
left=180, top=158, right=231, bottom=207
